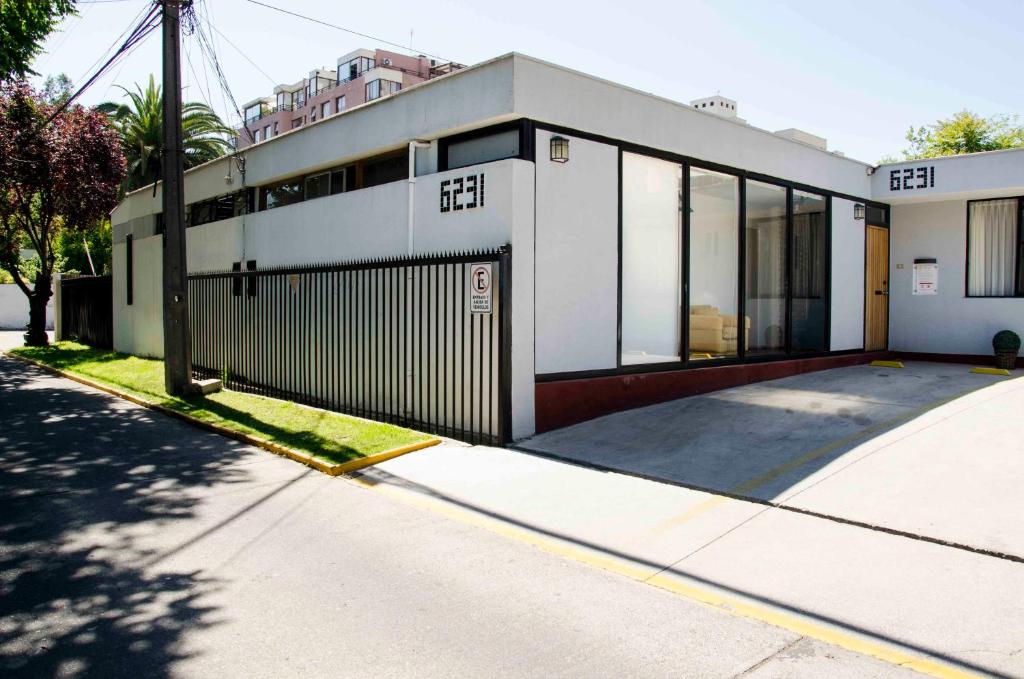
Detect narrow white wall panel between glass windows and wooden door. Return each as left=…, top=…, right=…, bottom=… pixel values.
left=829, top=198, right=864, bottom=351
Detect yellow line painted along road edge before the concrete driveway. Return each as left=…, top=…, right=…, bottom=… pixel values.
left=348, top=477, right=981, bottom=679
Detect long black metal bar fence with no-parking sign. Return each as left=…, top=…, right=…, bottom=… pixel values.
left=188, top=247, right=512, bottom=444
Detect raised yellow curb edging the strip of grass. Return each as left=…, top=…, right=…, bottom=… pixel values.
left=3, top=351, right=441, bottom=476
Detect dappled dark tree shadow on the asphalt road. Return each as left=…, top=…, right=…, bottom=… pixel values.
left=0, top=358, right=254, bottom=677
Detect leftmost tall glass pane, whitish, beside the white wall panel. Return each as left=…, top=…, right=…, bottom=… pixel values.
left=622, top=154, right=682, bottom=366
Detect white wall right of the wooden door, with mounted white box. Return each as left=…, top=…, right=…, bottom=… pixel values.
left=889, top=200, right=1024, bottom=354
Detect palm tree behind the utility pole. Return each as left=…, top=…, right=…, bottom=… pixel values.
left=96, top=75, right=236, bottom=192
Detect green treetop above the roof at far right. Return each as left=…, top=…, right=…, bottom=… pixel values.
left=903, top=110, right=1024, bottom=160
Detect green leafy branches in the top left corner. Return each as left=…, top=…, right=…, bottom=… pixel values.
left=0, top=0, right=75, bottom=81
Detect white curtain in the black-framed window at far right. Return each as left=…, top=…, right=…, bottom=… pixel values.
left=967, top=199, right=1017, bottom=297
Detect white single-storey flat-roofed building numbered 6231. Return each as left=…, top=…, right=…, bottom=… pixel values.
left=113, top=54, right=1024, bottom=446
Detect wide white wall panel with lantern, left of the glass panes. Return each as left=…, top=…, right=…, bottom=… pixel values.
left=536, top=130, right=618, bottom=374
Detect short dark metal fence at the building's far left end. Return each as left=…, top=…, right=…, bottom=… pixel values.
left=60, top=275, right=114, bottom=349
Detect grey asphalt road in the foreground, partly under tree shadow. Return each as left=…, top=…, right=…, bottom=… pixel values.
left=0, top=348, right=950, bottom=679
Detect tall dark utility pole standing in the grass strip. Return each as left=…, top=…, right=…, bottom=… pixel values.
left=161, top=0, right=198, bottom=396
